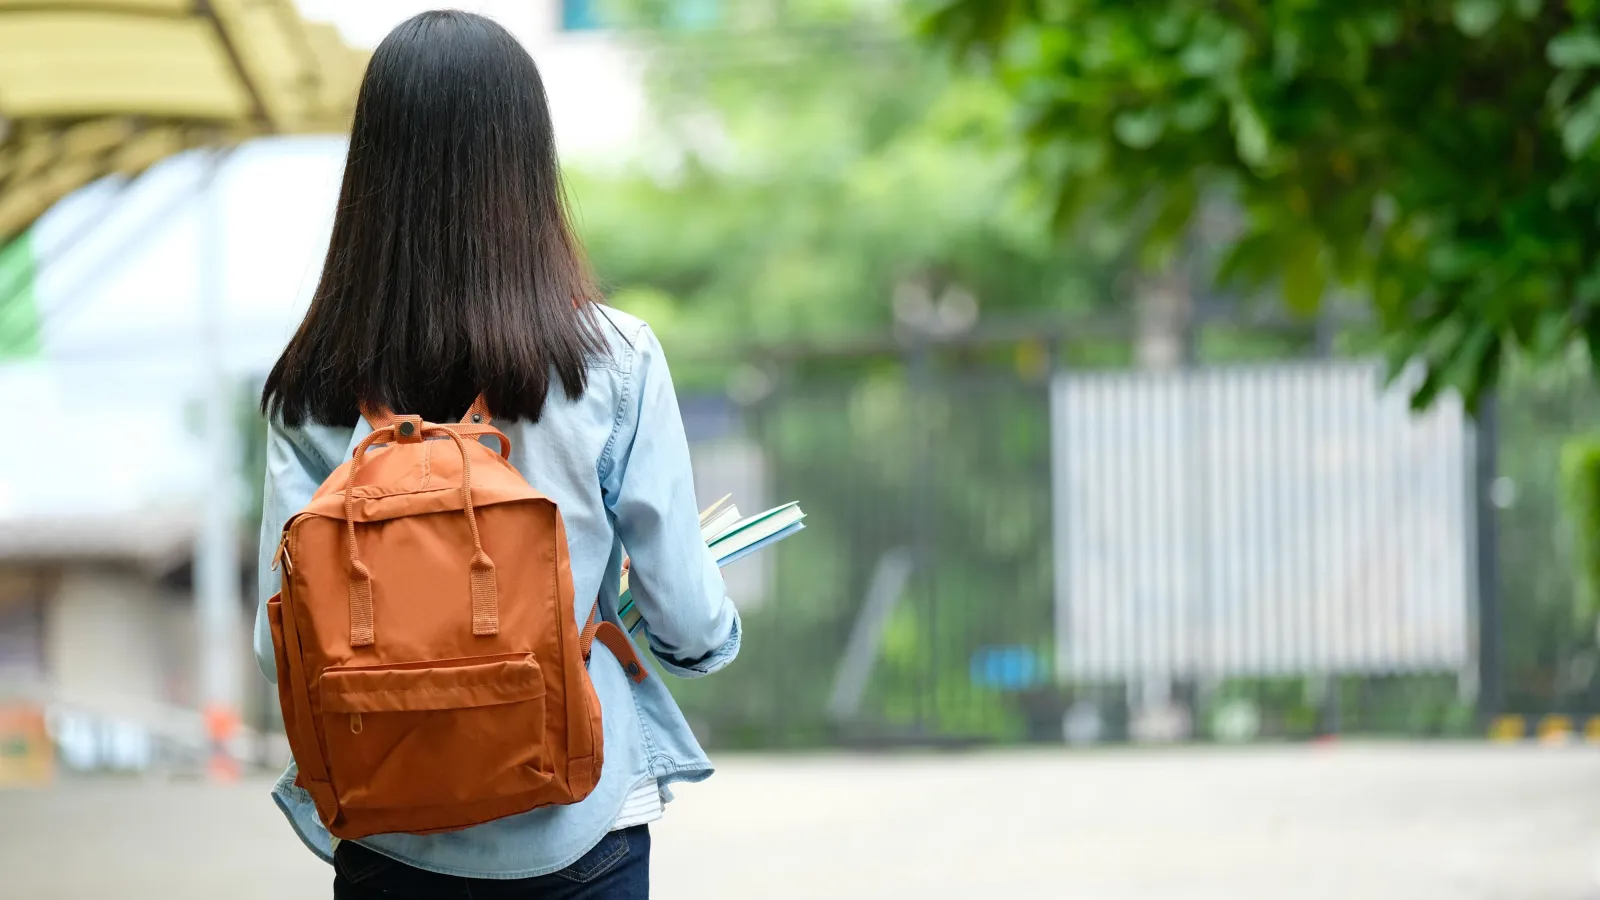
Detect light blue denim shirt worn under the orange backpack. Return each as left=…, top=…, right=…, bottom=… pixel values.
left=254, top=307, right=739, bottom=878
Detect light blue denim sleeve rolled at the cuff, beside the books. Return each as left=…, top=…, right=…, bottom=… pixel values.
left=602, top=328, right=739, bottom=677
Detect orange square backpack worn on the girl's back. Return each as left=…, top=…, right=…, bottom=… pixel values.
left=267, top=397, right=645, bottom=838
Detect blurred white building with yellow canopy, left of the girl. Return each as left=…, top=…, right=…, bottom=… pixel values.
left=0, top=0, right=365, bottom=764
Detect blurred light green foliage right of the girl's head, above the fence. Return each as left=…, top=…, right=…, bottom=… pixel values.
left=573, top=0, right=1112, bottom=381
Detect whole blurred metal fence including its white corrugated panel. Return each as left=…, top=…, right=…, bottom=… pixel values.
left=675, top=353, right=1600, bottom=746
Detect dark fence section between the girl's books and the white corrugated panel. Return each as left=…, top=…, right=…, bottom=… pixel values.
left=674, top=370, right=1059, bottom=746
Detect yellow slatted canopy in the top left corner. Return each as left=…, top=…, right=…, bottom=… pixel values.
left=0, top=0, right=366, bottom=238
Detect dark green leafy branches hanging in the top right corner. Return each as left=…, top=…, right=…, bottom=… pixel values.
left=914, top=0, right=1600, bottom=405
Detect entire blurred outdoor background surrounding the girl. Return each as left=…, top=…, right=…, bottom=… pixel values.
left=0, top=0, right=1600, bottom=900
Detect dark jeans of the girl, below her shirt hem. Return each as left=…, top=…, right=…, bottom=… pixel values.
left=333, top=825, right=650, bottom=900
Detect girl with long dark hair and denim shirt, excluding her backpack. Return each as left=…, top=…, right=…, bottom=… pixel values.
left=254, top=11, right=739, bottom=900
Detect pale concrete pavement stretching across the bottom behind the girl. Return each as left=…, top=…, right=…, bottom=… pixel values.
left=0, top=745, right=1600, bottom=900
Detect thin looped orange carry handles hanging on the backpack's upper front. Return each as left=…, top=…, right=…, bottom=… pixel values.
left=344, top=423, right=510, bottom=647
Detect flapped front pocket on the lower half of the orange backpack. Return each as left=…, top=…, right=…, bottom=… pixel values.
left=318, top=653, right=554, bottom=809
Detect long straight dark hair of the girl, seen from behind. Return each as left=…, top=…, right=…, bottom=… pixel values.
left=261, top=11, right=605, bottom=424
